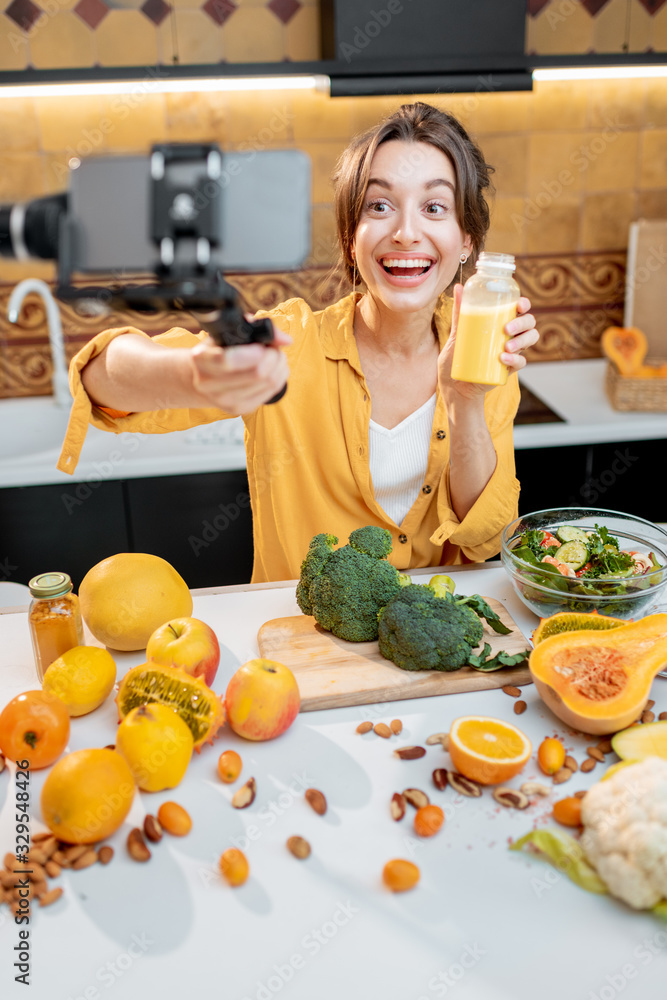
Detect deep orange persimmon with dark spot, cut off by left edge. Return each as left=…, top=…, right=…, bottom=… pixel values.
left=0, top=691, right=70, bottom=770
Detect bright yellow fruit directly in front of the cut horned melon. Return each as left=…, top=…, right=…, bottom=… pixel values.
left=116, top=703, right=194, bottom=792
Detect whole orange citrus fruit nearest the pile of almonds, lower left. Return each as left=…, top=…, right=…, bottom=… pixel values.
left=40, top=747, right=135, bottom=844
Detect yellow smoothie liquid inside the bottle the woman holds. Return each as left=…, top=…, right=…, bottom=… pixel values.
left=452, top=302, right=516, bottom=385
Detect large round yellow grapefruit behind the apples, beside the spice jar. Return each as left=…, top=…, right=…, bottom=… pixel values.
left=79, top=552, right=193, bottom=651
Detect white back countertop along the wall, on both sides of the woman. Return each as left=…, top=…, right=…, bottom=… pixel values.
left=0, top=359, right=667, bottom=488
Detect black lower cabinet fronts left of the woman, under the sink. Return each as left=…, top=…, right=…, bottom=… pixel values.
left=0, top=470, right=252, bottom=590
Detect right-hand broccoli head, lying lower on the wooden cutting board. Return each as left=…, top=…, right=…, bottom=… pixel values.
left=379, top=584, right=484, bottom=670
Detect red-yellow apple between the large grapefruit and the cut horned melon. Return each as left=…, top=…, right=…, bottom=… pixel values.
left=146, top=618, right=220, bottom=687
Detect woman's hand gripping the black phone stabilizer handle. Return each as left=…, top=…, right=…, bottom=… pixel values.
left=191, top=326, right=292, bottom=416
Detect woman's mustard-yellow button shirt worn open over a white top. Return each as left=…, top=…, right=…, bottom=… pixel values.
left=58, top=295, right=519, bottom=583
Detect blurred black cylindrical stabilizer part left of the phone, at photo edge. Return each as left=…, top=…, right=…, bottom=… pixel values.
left=0, top=194, right=67, bottom=260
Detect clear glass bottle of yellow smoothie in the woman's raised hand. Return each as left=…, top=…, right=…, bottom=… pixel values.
left=452, top=253, right=521, bottom=385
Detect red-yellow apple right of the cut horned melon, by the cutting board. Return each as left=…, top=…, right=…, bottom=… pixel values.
left=225, top=659, right=301, bottom=740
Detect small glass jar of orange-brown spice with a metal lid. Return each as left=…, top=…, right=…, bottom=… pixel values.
left=28, top=573, right=83, bottom=681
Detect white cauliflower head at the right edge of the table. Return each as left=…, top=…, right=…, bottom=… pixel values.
left=581, top=757, right=667, bottom=910
